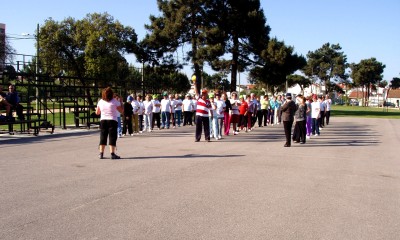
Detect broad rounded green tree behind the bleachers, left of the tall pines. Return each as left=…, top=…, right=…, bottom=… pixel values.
left=38, top=13, right=137, bottom=102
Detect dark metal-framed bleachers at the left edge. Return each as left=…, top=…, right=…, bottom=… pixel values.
left=0, top=55, right=125, bottom=134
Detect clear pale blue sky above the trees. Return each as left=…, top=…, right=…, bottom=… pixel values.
left=0, top=0, right=400, bottom=81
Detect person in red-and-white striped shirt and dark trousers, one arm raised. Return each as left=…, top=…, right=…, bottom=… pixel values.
left=194, top=81, right=213, bottom=142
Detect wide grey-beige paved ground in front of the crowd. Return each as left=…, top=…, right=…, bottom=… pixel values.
left=0, top=118, right=400, bottom=240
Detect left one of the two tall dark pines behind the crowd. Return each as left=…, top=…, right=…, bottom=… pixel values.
left=142, top=0, right=210, bottom=94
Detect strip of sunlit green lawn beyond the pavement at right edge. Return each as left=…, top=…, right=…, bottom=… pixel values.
left=331, top=105, right=400, bottom=119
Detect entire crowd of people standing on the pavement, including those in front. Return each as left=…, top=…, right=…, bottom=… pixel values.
left=96, top=88, right=332, bottom=159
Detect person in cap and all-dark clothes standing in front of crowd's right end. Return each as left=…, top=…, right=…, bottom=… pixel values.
left=280, top=93, right=296, bottom=147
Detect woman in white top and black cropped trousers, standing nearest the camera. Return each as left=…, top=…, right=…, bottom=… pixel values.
left=96, top=87, right=123, bottom=159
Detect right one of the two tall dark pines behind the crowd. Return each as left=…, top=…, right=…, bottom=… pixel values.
left=205, top=0, right=270, bottom=91
